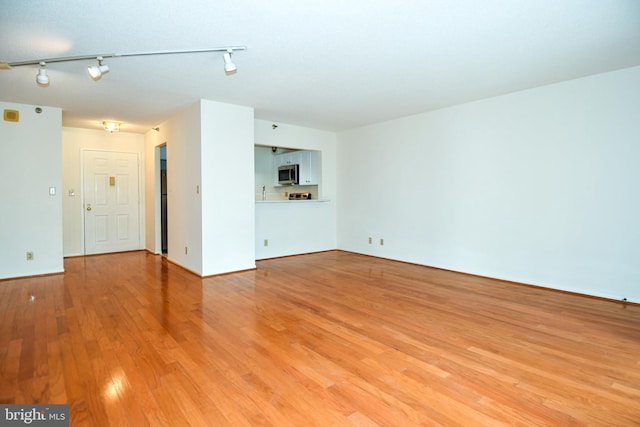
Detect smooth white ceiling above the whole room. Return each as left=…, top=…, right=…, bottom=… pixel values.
left=0, top=0, right=640, bottom=132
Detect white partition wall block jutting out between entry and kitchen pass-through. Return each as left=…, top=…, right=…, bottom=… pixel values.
left=145, top=100, right=255, bottom=276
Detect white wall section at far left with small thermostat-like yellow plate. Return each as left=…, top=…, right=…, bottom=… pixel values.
left=0, top=102, right=64, bottom=279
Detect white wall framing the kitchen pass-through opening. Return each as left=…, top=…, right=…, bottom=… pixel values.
left=253, top=120, right=338, bottom=259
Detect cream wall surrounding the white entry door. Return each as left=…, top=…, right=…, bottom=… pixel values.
left=60, top=127, right=145, bottom=256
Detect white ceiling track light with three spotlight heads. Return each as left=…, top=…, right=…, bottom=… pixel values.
left=0, top=46, right=247, bottom=87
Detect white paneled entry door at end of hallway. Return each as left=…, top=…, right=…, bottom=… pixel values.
left=82, top=150, right=140, bottom=255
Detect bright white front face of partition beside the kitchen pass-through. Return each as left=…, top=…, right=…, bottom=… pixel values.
left=200, top=100, right=255, bottom=276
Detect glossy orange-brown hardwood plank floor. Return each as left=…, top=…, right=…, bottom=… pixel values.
left=0, top=252, right=640, bottom=427
